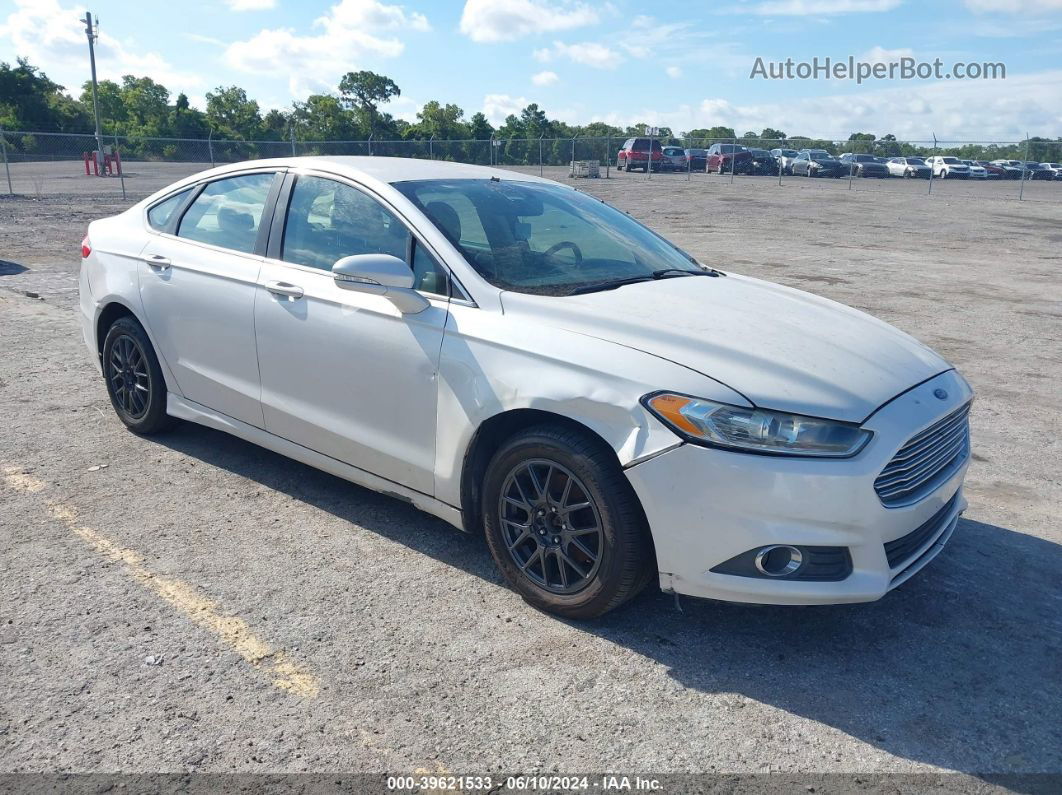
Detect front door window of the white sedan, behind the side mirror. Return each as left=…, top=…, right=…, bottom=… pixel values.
left=280, top=176, right=410, bottom=271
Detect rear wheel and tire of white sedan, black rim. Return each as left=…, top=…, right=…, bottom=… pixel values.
left=103, top=316, right=176, bottom=436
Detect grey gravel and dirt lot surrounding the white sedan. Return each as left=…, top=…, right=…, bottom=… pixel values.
left=0, top=164, right=1062, bottom=790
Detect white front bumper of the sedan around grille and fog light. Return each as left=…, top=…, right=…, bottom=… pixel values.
left=626, top=370, right=973, bottom=605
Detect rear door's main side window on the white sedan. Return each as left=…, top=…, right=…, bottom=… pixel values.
left=177, top=174, right=274, bottom=254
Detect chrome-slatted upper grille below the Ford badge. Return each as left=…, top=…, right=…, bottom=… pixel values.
left=874, top=403, right=970, bottom=507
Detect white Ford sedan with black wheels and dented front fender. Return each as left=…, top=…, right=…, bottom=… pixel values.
left=81, top=157, right=973, bottom=618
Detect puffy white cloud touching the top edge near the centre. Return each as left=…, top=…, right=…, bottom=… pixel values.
left=461, top=0, right=599, bottom=41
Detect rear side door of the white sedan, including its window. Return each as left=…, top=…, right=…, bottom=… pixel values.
left=139, top=169, right=281, bottom=428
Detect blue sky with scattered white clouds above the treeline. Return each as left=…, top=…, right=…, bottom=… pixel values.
left=0, top=0, right=1062, bottom=141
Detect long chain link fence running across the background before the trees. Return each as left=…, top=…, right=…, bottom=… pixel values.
left=0, top=131, right=1062, bottom=202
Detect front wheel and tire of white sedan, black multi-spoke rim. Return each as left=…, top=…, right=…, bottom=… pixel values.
left=482, top=425, right=655, bottom=619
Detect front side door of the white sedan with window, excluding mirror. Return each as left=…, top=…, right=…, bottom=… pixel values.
left=255, top=174, right=448, bottom=495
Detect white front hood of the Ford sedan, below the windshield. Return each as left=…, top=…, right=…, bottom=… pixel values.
left=502, top=275, right=950, bottom=421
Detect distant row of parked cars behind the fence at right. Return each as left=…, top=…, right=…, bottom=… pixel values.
left=616, top=138, right=1062, bottom=180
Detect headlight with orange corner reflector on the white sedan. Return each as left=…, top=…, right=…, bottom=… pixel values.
left=643, top=393, right=872, bottom=459
